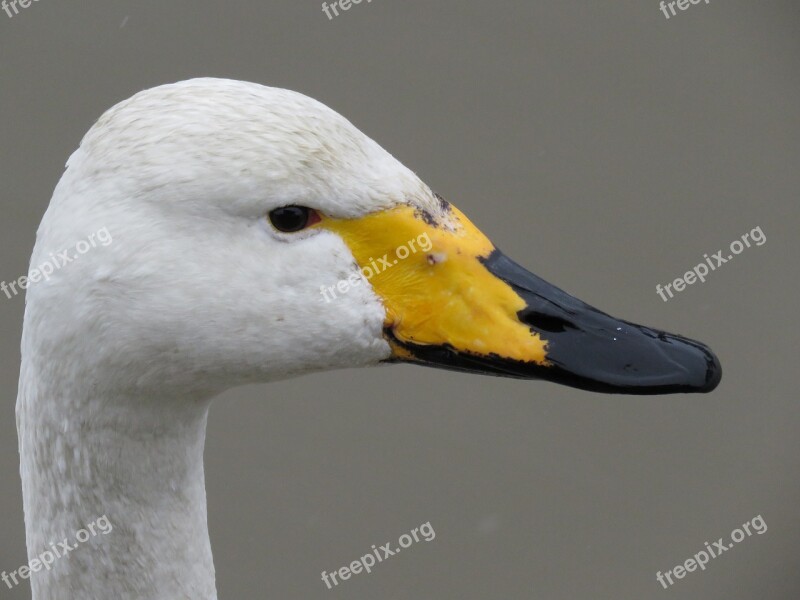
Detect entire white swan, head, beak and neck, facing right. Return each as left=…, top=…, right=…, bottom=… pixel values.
left=16, top=78, right=721, bottom=600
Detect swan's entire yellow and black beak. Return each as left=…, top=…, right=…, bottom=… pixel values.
left=323, top=201, right=722, bottom=394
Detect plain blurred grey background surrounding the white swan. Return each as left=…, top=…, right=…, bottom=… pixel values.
left=0, top=0, right=800, bottom=600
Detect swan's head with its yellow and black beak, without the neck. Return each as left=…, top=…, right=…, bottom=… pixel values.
left=26, top=79, right=720, bottom=393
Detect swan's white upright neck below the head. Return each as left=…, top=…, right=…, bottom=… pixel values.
left=17, top=356, right=216, bottom=600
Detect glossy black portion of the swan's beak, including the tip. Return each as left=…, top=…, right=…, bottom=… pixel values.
left=386, top=250, right=722, bottom=394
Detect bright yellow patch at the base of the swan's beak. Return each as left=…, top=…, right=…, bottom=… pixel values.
left=319, top=205, right=548, bottom=366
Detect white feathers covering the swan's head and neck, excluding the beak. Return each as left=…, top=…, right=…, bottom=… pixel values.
left=17, top=79, right=439, bottom=600
